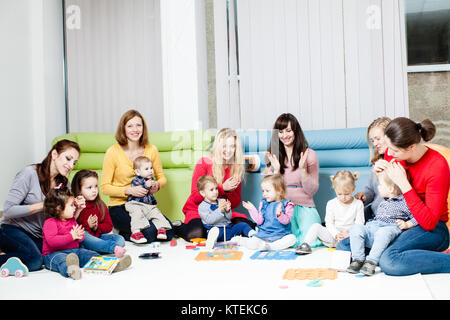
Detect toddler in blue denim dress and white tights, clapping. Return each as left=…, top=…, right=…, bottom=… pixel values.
left=231, top=174, right=297, bottom=250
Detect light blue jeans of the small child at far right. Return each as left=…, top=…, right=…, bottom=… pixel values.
left=350, top=220, right=402, bottom=265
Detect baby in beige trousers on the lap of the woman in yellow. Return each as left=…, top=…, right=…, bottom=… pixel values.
left=125, top=156, right=172, bottom=243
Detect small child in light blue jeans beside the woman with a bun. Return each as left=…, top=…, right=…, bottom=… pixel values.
left=347, top=171, right=417, bottom=276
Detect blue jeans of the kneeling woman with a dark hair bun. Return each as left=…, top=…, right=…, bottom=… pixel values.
left=336, top=221, right=450, bottom=276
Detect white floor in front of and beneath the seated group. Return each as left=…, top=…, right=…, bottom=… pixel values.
left=0, top=239, right=450, bottom=300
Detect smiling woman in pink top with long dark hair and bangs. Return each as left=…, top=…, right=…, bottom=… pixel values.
left=267, top=113, right=322, bottom=248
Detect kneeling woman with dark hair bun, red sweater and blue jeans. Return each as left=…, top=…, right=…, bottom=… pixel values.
left=379, top=117, right=450, bottom=275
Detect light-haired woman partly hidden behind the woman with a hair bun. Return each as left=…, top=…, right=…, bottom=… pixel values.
left=355, top=117, right=391, bottom=221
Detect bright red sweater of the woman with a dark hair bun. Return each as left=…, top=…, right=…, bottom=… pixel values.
left=384, top=148, right=450, bottom=231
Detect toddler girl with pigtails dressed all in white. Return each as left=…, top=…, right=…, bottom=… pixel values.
left=295, top=170, right=364, bottom=254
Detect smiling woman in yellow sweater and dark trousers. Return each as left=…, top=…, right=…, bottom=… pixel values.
left=100, top=110, right=173, bottom=243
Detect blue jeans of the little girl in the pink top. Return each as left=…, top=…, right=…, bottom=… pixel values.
left=44, top=248, right=99, bottom=278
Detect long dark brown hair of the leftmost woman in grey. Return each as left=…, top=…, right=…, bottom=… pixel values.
left=35, top=139, right=81, bottom=196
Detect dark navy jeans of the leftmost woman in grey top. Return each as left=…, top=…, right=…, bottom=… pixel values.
left=0, top=224, right=42, bottom=271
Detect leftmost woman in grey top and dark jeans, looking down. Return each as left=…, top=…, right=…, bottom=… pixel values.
left=0, top=140, right=84, bottom=271
